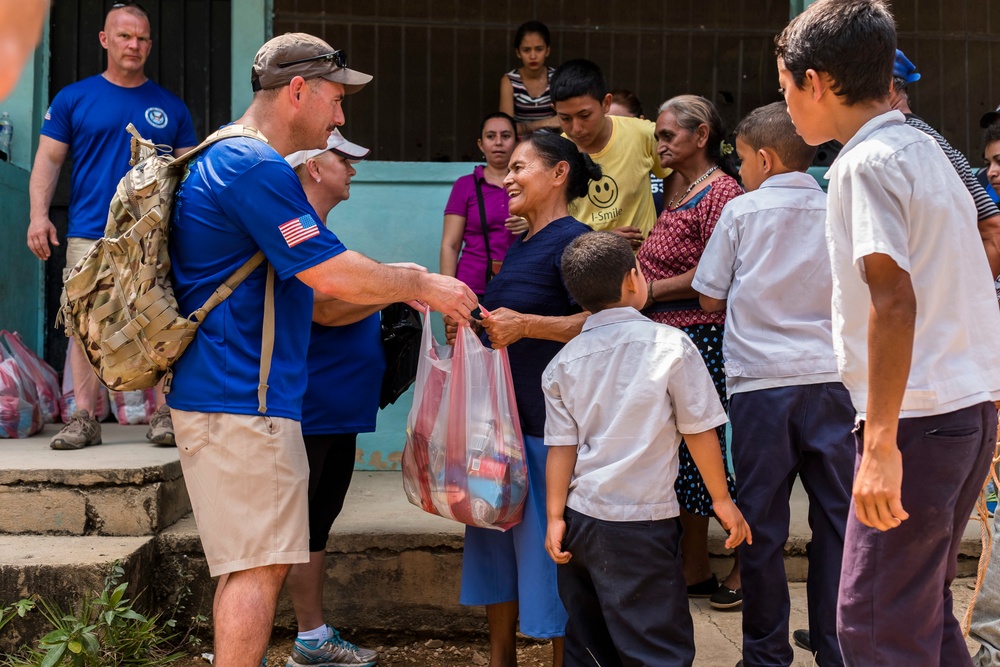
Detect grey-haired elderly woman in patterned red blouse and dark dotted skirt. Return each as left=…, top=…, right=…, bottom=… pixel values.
left=636, top=95, right=743, bottom=609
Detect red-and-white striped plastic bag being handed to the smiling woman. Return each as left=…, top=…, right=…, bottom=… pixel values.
left=402, top=314, right=528, bottom=530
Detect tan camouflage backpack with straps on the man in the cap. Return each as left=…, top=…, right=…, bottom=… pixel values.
left=62, top=123, right=274, bottom=413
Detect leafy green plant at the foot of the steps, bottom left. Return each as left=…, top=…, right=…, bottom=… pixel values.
left=0, top=562, right=184, bottom=667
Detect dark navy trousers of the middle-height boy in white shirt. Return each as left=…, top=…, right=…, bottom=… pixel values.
left=729, top=382, right=855, bottom=667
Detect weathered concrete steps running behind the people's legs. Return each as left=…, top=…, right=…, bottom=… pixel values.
left=0, top=424, right=980, bottom=650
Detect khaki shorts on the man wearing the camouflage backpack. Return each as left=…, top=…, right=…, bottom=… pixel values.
left=170, top=409, right=309, bottom=577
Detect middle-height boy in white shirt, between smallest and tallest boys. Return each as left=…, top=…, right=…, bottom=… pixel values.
left=691, top=102, right=854, bottom=667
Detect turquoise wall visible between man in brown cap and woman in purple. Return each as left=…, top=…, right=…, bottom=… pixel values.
left=327, top=160, right=474, bottom=470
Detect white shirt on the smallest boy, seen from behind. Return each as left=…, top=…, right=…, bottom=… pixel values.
left=542, top=308, right=726, bottom=521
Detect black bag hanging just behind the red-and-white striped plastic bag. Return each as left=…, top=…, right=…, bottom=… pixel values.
left=378, top=303, right=424, bottom=410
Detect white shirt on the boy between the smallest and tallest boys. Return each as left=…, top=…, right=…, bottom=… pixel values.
left=691, top=172, right=840, bottom=394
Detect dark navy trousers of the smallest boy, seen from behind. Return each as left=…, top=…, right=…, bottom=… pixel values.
left=557, top=508, right=694, bottom=667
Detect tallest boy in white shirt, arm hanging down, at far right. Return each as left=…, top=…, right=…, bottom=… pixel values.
left=777, top=0, right=1000, bottom=667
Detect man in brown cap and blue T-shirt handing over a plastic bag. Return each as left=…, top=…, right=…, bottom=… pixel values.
left=168, top=33, right=476, bottom=667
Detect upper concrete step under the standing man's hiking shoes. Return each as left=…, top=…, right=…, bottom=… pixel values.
left=0, top=424, right=191, bottom=536
